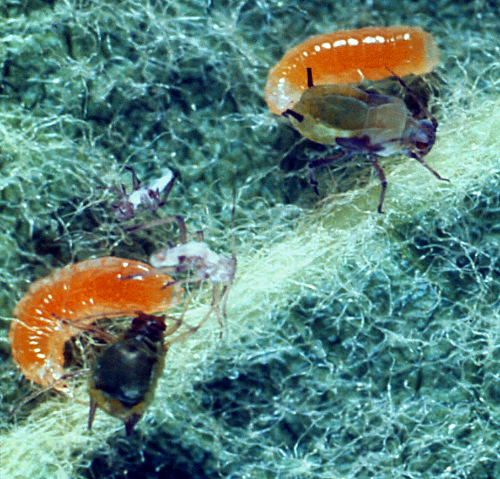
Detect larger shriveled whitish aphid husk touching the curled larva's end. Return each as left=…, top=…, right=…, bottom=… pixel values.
left=129, top=216, right=237, bottom=336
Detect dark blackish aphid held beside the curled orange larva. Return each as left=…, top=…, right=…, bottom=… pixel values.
left=88, top=312, right=174, bottom=436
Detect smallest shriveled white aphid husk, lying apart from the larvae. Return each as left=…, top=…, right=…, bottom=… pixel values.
left=110, top=166, right=177, bottom=221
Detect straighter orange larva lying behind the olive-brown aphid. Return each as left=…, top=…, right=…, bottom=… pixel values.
left=265, top=26, right=439, bottom=115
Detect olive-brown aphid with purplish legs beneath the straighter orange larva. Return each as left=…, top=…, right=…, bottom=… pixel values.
left=283, top=68, right=449, bottom=213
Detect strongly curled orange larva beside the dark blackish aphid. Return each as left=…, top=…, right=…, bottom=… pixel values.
left=9, top=256, right=183, bottom=389
